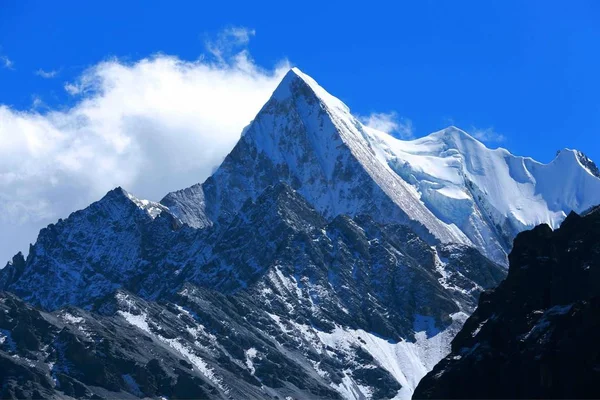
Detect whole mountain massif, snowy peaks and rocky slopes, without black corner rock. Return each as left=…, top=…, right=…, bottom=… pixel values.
left=0, top=68, right=600, bottom=399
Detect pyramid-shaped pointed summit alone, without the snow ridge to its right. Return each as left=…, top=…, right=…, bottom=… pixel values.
left=161, top=68, right=470, bottom=243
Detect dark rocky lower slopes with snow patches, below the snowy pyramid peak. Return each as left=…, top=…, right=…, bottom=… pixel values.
left=0, top=184, right=504, bottom=398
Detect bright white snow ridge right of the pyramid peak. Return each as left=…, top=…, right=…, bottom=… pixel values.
left=368, top=127, right=600, bottom=261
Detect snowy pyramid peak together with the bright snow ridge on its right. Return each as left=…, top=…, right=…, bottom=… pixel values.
left=161, top=68, right=600, bottom=265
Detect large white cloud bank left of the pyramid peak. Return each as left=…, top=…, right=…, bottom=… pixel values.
left=0, top=31, right=289, bottom=266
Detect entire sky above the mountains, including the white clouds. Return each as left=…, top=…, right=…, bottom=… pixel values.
left=0, top=0, right=600, bottom=263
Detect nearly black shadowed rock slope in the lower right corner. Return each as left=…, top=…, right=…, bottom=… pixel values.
left=414, top=208, right=600, bottom=398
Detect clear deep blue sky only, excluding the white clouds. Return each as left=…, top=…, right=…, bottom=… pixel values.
left=0, top=0, right=600, bottom=162
